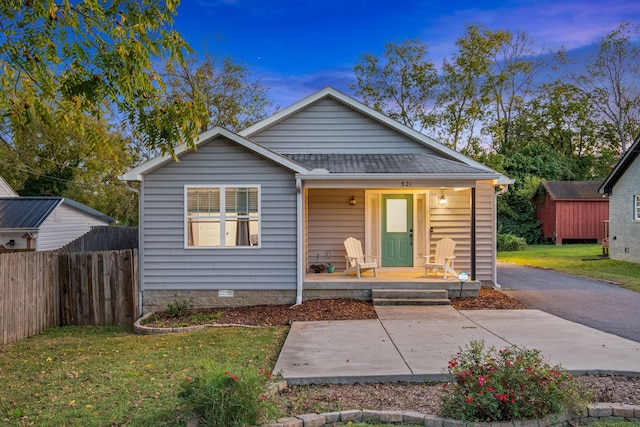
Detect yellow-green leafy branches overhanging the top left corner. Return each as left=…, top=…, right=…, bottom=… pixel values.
left=0, top=0, right=204, bottom=152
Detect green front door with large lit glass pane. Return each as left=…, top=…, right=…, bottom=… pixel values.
left=382, top=194, right=413, bottom=267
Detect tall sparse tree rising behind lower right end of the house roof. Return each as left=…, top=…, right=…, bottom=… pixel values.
left=439, top=25, right=542, bottom=156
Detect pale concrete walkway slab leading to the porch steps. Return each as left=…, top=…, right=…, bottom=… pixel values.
left=274, top=306, right=640, bottom=384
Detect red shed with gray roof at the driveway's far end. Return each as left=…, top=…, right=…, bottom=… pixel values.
left=532, top=181, right=609, bottom=245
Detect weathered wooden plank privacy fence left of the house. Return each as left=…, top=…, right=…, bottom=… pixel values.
left=0, top=249, right=139, bottom=345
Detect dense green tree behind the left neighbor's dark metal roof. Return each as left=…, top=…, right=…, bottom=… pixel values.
left=0, top=108, right=137, bottom=225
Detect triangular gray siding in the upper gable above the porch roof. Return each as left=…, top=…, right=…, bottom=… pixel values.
left=251, top=99, right=437, bottom=154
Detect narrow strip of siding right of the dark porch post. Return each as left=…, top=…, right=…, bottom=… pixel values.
left=476, top=181, right=496, bottom=283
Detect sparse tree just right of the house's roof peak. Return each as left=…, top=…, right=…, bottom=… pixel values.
left=349, top=40, right=438, bottom=131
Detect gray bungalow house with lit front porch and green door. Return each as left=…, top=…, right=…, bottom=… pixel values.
left=121, top=88, right=508, bottom=312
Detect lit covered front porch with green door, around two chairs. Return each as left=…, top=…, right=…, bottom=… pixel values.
left=302, top=181, right=493, bottom=300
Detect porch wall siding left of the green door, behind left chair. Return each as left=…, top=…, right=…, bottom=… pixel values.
left=307, top=188, right=365, bottom=271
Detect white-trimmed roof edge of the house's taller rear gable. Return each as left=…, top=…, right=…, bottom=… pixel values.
left=239, top=87, right=495, bottom=173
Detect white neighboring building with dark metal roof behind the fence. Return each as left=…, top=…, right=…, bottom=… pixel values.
left=0, top=196, right=115, bottom=251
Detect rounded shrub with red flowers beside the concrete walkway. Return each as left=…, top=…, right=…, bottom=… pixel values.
left=440, top=341, right=588, bottom=422
